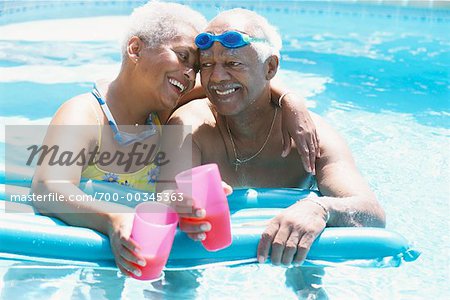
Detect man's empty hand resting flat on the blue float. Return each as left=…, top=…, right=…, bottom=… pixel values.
left=257, top=196, right=327, bottom=265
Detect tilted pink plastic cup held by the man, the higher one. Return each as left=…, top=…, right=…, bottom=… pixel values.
left=175, top=164, right=232, bottom=251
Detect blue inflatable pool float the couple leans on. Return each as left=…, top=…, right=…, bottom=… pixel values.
left=0, top=174, right=420, bottom=269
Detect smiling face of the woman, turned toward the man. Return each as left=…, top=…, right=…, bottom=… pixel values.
left=140, top=25, right=198, bottom=109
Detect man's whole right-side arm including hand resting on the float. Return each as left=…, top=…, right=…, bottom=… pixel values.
left=258, top=116, right=385, bottom=265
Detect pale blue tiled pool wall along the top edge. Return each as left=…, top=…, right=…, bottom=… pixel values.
left=0, top=0, right=450, bottom=25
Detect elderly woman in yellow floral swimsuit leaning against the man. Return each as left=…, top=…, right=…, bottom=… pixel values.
left=33, top=2, right=317, bottom=276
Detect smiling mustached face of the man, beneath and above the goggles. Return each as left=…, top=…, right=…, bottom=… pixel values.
left=200, top=22, right=268, bottom=115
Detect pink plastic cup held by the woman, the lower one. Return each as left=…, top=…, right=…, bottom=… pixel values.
left=131, top=202, right=178, bottom=280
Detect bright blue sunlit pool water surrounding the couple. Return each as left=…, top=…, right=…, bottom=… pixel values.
left=0, top=1, right=450, bottom=299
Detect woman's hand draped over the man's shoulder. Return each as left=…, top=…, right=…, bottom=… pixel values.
left=281, top=93, right=320, bottom=174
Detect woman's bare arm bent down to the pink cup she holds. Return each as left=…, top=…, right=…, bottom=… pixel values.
left=31, top=96, right=144, bottom=274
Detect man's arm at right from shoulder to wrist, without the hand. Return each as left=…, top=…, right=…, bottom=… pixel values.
left=315, top=118, right=386, bottom=227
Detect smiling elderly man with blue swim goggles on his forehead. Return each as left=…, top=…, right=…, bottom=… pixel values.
left=170, top=9, right=385, bottom=265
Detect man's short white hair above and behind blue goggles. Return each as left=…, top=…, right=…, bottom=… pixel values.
left=211, top=8, right=282, bottom=62
